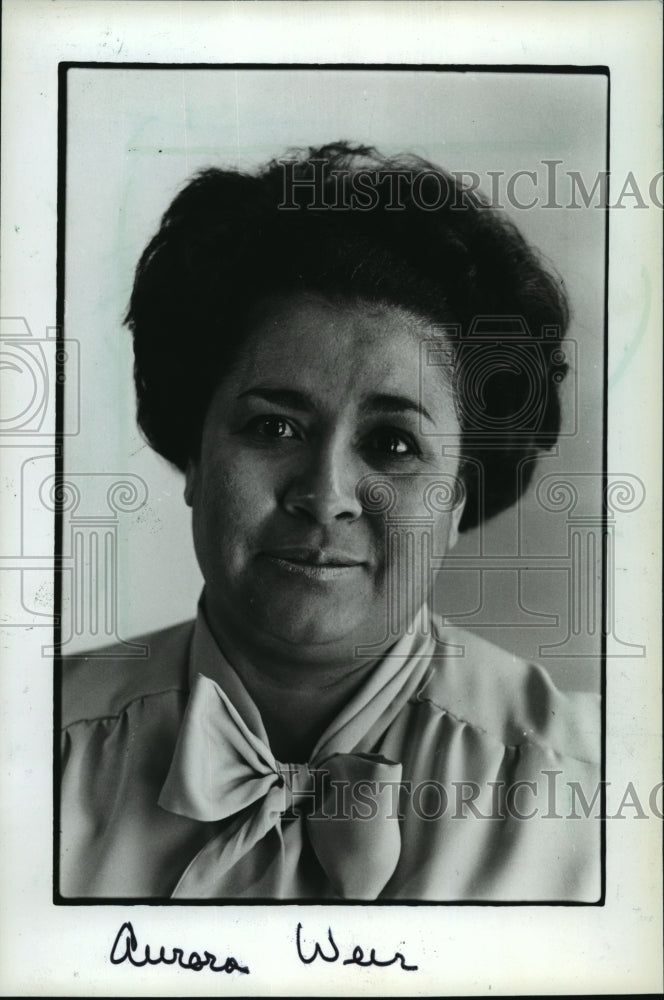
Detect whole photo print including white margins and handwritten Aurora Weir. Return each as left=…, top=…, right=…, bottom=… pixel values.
left=0, top=3, right=662, bottom=995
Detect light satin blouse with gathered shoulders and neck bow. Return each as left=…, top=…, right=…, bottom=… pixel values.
left=60, top=611, right=600, bottom=902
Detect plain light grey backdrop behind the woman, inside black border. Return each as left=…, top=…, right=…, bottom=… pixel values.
left=63, top=68, right=607, bottom=689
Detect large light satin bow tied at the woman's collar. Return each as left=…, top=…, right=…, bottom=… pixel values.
left=159, top=674, right=402, bottom=899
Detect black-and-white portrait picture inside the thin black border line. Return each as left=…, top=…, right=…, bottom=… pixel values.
left=59, top=66, right=607, bottom=902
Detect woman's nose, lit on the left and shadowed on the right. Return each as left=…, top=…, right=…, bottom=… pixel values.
left=283, top=444, right=362, bottom=524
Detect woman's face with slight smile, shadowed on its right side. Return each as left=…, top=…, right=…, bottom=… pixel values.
left=185, top=296, right=462, bottom=662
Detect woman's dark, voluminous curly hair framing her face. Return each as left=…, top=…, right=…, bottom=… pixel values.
left=125, top=142, right=569, bottom=530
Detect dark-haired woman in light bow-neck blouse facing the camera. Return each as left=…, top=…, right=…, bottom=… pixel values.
left=61, top=143, right=599, bottom=901
